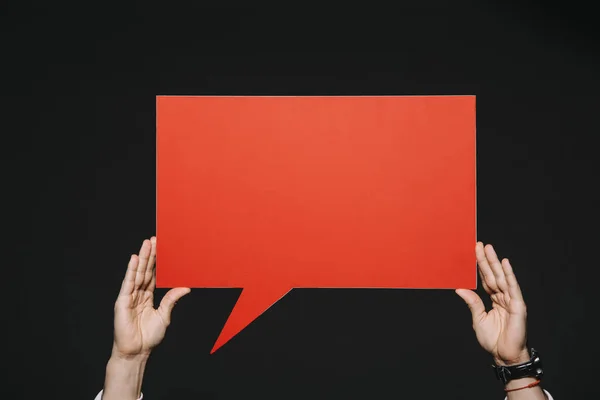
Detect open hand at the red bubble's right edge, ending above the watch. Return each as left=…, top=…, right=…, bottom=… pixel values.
left=456, top=242, right=530, bottom=365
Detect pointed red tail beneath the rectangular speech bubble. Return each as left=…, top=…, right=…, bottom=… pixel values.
left=210, top=287, right=291, bottom=354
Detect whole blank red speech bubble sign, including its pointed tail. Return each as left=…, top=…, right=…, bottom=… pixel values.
left=157, top=96, right=476, bottom=353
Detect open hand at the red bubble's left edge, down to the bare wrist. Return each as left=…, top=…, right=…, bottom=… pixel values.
left=113, top=237, right=190, bottom=359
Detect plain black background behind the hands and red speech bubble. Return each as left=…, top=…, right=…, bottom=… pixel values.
left=5, top=2, right=600, bottom=399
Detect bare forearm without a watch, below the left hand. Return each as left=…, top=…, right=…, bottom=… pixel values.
left=102, top=354, right=148, bottom=400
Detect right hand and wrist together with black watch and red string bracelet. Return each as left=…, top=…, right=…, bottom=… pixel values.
left=456, top=242, right=549, bottom=400
